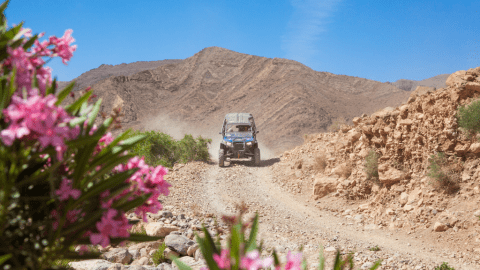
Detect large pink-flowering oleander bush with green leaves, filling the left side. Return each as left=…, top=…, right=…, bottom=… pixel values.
left=0, top=1, right=170, bottom=269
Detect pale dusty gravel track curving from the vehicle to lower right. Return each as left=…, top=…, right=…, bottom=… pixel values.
left=165, top=158, right=479, bottom=269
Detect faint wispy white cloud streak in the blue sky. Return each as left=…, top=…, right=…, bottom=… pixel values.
left=282, top=0, right=341, bottom=64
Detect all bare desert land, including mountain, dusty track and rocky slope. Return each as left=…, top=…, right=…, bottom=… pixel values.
left=60, top=47, right=480, bottom=269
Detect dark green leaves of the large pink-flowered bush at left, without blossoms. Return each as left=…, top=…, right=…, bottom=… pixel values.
left=0, top=2, right=163, bottom=269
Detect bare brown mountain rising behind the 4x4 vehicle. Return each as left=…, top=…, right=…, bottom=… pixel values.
left=88, top=47, right=409, bottom=151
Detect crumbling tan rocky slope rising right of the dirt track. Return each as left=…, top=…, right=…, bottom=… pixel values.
left=274, top=67, right=480, bottom=261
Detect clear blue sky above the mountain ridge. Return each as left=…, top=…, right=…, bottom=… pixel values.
left=6, top=0, right=480, bottom=82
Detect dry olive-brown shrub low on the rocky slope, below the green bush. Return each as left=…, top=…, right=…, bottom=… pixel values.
left=427, top=152, right=460, bottom=193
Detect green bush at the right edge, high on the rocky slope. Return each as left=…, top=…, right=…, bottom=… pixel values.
left=457, top=100, right=480, bottom=138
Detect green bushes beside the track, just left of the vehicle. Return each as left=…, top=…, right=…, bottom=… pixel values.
left=126, top=131, right=212, bottom=167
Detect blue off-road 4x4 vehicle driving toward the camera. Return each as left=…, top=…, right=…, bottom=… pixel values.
left=218, top=113, right=260, bottom=167
